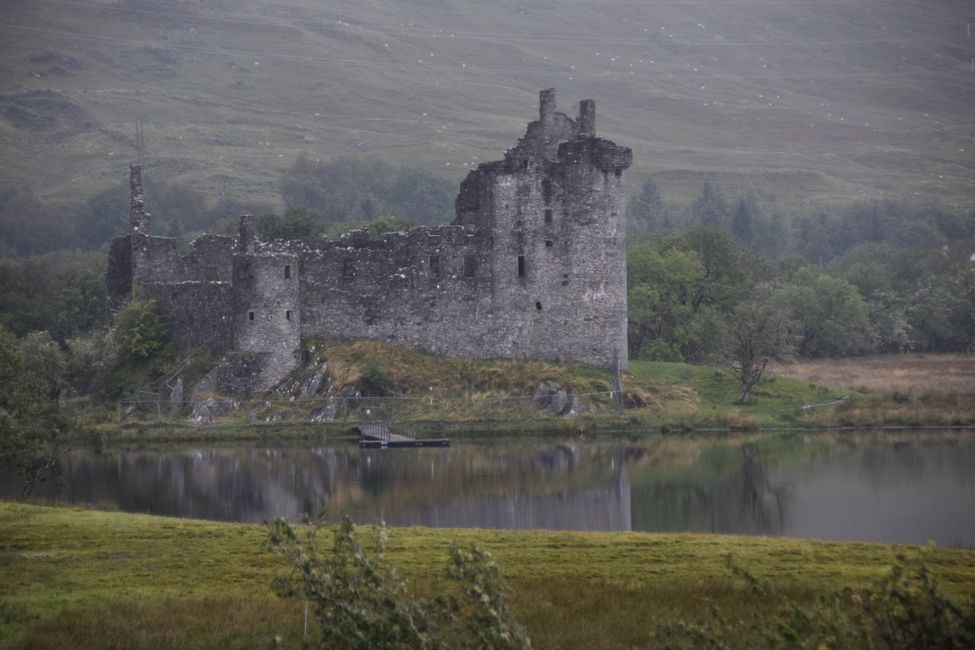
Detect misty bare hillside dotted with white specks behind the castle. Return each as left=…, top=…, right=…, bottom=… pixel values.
left=0, top=0, right=975, bottom=208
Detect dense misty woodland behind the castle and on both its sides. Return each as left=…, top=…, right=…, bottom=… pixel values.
left=0, top=163, right=975, bottom=398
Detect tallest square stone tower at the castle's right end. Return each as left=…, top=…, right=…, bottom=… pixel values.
left=455, top=90, right=632, bottom=367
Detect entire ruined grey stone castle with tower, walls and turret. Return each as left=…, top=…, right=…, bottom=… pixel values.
left=107, top=90, right=632, bottom=389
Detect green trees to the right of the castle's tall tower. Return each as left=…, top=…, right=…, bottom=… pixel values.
left=627, top=181, right=975, bottom=400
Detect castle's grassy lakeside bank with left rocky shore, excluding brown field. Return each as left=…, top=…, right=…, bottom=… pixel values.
left=112, top=340, right=851, bottom=441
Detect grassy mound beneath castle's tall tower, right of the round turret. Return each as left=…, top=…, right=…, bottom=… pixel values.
left=264, top=341, right=850, bottom=430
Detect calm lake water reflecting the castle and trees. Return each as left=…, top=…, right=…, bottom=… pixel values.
left=0, top=432, right=975, bottom=546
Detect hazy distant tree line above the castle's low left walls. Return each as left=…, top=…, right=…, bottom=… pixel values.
left=0, top=156, right=456, bottom=258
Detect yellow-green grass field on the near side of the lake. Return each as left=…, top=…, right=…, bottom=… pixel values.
left=0, top=502, right=975, bottom=648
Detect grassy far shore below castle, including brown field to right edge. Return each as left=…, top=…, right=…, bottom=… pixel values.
left=97, top=341, right=975, bottom=442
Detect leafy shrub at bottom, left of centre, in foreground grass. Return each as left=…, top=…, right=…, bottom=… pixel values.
left=268, top=517, right=531, bottom=649
